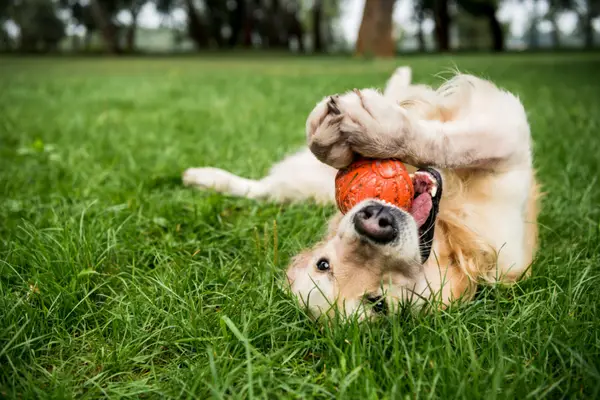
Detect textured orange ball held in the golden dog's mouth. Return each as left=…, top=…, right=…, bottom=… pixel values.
left=335, top=159, right=415, bottom=214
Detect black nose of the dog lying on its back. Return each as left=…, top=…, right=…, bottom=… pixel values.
left=354, top=204, right=398, bottom=243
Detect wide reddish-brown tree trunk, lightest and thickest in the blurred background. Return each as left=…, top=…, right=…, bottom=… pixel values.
left=356, top=0, right=396, bottom=57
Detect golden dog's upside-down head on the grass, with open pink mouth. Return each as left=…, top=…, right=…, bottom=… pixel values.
left=287, top=172, right=441, bottom=319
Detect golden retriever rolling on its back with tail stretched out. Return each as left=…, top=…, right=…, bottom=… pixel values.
left=183, top=67, right=540, bottom=319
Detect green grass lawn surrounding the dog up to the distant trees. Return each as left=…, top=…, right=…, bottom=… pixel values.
left=0, top=54, right=600, bottom=399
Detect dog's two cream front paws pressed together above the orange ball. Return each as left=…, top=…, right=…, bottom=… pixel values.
left=306, top=89, right=408, bottom=168
